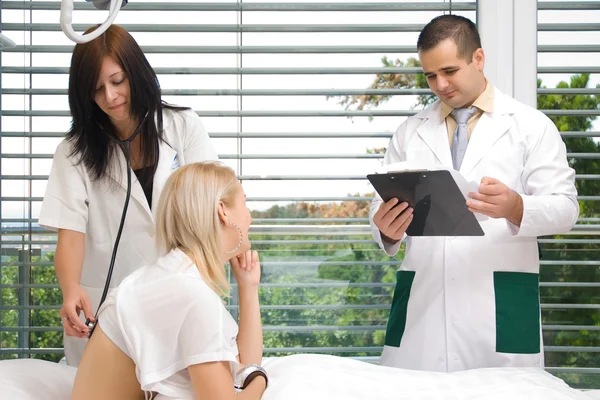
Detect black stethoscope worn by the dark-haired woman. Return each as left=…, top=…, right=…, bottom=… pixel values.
left=85, top=111, right=149, bottom=338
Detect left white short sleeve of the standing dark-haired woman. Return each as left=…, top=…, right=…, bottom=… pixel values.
left=39, top=140, right=88, bottom=233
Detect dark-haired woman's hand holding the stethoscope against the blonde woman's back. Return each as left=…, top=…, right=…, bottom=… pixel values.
left=59, top=285, right=96, bottom=339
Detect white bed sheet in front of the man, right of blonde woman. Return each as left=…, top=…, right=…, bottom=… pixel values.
left=262, top=354, right=592, bottom=400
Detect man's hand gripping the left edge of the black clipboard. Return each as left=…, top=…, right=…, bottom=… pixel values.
left=373, top=198, right=413, bottom=244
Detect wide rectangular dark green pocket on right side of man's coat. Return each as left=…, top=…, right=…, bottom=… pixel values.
left=494, top=271, right=540, bottom=354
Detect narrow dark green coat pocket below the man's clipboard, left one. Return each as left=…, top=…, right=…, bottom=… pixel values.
left=385, top=271, right=415, bottom=347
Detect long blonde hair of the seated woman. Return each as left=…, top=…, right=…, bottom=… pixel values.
left=156, top=161, right=238, bottom=296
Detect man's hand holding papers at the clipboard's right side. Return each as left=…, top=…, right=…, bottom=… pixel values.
left=467, top=177, right=523, bottom=226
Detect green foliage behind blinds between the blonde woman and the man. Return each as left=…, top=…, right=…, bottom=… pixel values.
left=251, top=228, right=396, bottom=356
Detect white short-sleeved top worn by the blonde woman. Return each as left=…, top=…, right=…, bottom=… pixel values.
left=98, top=249, right=238, bottom=399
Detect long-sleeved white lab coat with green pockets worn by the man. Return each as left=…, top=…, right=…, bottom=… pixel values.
left=371, top=89, right=579, bottom=371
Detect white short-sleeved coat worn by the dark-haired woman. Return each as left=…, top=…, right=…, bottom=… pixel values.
left=39, top=109, right=218, bottom=365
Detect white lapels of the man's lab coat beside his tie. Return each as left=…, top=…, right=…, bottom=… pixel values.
left=414, top=87, right=523, bottom=176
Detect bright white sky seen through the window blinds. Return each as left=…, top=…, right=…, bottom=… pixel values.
left=2, top=0, right=600, bottom=222
